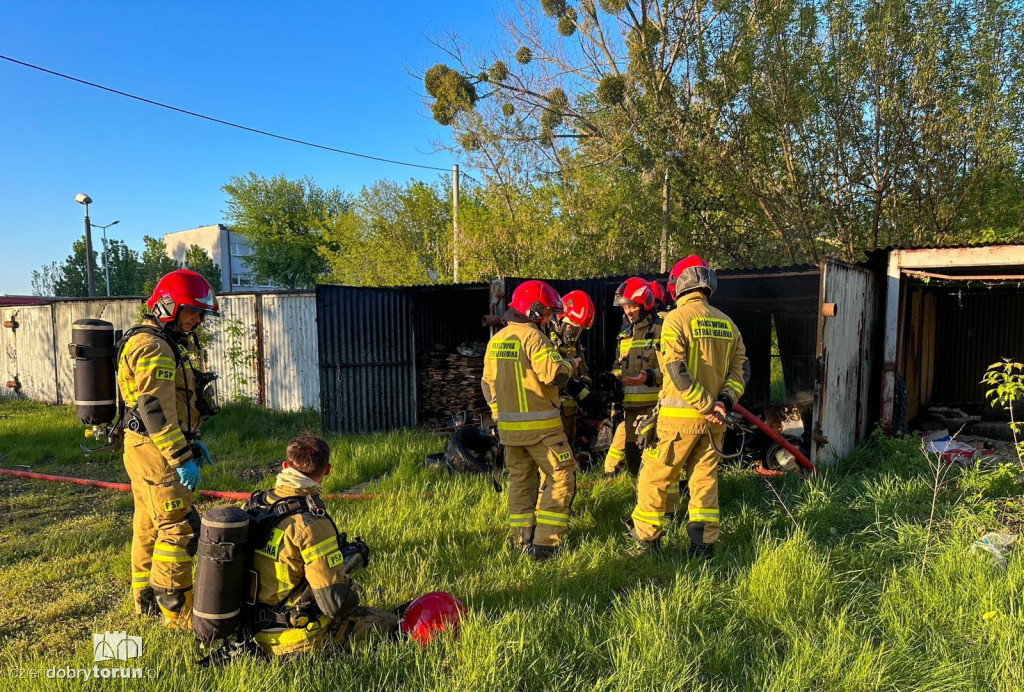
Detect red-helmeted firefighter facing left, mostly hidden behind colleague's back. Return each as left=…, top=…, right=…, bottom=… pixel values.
left=548, top=291, right=604, bottom=449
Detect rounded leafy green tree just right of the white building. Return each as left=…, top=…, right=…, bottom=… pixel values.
left=223, top=172, right=351, bottom=289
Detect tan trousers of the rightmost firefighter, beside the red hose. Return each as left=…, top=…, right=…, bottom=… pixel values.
left=633, top=426, right=725, bottom=545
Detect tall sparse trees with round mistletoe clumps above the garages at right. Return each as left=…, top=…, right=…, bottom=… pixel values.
left=424, top=0, right=1024, bottom=263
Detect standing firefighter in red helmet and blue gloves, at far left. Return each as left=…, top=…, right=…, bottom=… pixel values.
left=118, top=269, right=218, bottom=628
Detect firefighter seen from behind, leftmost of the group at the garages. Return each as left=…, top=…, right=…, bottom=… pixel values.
left=480, top=280, right=580, bottom=560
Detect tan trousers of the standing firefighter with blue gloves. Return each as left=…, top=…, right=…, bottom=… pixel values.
left=125, top=432, right=200, bottom=612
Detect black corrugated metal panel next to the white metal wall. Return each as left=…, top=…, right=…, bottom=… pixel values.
left=316, top=286, right=417, bottom=433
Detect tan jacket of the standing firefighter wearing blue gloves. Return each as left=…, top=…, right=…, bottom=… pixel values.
left=118, top=316, right=200, bottom=466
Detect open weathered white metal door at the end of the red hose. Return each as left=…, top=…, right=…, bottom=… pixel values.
left=814, top=260, right=879, bottom=464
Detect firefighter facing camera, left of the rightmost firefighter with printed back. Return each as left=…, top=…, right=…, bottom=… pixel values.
left=604, top=276, right=662, bottom=476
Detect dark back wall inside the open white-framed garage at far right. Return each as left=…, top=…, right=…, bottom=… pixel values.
left=932, top=289, right=1024, bottom=403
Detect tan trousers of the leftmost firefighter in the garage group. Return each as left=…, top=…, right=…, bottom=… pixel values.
left=505, top=431, right=577, bottom=548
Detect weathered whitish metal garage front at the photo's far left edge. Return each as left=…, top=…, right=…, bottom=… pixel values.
left=0, top=305, right=58, bottom=403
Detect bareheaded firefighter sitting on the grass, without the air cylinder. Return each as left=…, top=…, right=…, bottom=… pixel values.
left=246, top=434, right=399, bottom=655
